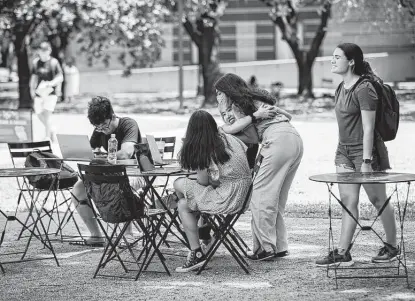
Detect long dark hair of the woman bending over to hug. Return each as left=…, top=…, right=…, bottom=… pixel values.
left=214, top=73, right=275, bottom=115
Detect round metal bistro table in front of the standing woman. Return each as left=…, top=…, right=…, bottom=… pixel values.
left=309, top=172, right=415, bottom=288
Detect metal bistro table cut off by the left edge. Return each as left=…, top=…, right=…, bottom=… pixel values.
left=0, top=167, right=60, bottom=274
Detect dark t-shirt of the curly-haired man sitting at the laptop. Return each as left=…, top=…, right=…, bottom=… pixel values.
left=90, top=117, right=141, bottom=151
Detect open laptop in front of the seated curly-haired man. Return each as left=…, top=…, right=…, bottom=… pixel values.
left=56, top=134, right=94, bottom=161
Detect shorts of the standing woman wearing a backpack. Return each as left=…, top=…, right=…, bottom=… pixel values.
left=334, top=144, right=381, bottom=171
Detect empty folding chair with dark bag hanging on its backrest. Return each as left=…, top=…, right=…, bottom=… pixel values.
left=78, top=164, right=170, bottom=280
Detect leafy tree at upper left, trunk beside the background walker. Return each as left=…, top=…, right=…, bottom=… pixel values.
left=0, top=0, right=168, bottom=107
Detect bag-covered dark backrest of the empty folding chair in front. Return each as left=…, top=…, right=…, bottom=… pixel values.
left=78, top=164, right=144, bottom=223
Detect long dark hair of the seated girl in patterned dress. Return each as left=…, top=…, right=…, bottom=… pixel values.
left=179, top=110, right=230, bottom=170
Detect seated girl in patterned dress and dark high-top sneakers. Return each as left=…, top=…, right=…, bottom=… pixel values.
left=174, top=110, right=251, bottom=272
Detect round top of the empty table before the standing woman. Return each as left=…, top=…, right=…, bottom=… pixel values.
left=309, top=171, right=415, bottom=184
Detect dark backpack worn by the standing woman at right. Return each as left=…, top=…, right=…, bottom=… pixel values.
left=336, top=76, right=399, bottom=141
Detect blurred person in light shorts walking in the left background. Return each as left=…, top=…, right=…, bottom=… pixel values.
left=30, top=42, right=63, bottom=141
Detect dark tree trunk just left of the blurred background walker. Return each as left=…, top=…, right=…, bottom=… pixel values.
left=14, top=32, right=33, bottom=109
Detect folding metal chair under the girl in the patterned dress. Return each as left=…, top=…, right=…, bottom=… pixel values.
left=197, top=154, right=264, bottom=275
